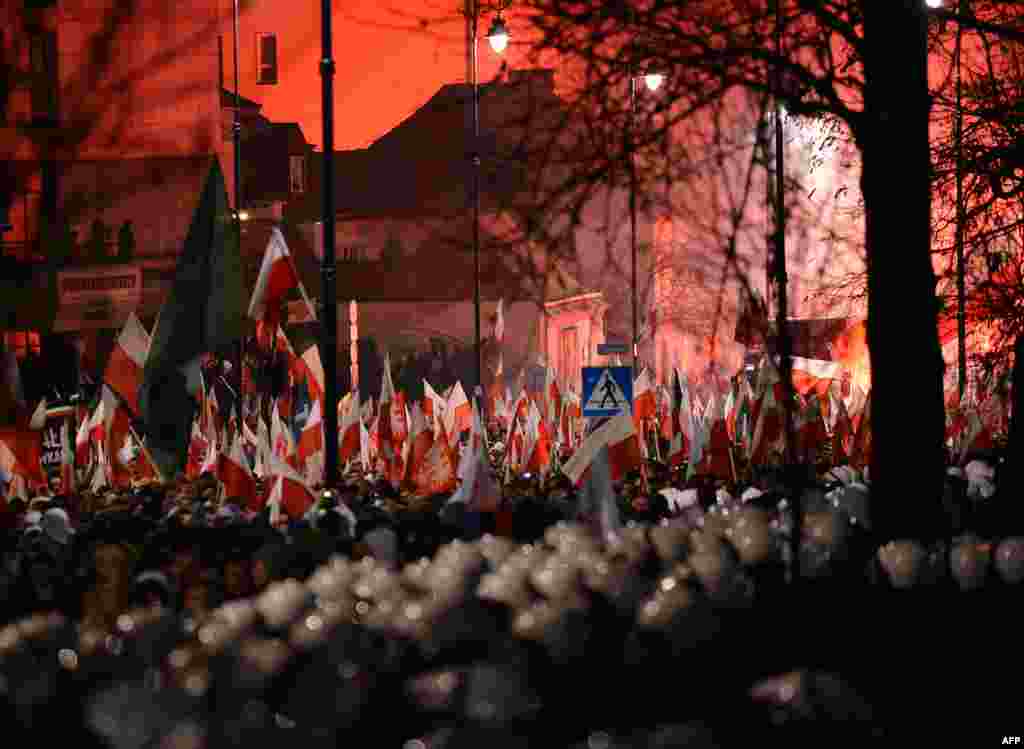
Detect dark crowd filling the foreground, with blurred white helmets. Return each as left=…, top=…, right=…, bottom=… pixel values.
left=0, top=415, right=1024, bottom=749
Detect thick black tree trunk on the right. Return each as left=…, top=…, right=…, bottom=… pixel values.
left=857, top=0, right=945, bottom=541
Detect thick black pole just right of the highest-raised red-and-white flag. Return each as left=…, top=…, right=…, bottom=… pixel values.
left=319, top=0, right=339, bottom=487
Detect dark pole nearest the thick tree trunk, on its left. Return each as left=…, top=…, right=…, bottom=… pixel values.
left=774, top=0, right=803, bottom=580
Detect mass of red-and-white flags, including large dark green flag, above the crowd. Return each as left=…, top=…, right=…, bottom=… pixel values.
left=0, top=157, right=1010, bottom=532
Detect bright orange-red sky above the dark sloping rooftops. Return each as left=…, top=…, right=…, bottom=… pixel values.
left=235, top=0, right=525, bottom=150
